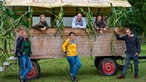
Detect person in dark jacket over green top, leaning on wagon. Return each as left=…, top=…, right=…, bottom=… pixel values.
left=15, top=32, right=32, bottom=82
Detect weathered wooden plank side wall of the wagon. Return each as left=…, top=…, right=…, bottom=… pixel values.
left=16, top=28, right=125, bottom=59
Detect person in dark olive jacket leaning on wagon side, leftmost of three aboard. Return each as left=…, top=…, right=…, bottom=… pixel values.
left=32, top=15, right=49, bottom=31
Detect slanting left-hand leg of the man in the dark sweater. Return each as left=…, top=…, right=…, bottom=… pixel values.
left=121, top=54, right=131, bottom=76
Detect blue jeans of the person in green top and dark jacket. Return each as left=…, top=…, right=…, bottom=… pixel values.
left=18, top=54, right=32, bottom=79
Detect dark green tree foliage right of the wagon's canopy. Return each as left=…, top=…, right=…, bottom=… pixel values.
left=109, top=0, right=146, bottom=35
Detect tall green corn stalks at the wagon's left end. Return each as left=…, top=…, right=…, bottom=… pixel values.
left=0, top=5, right=29, bottom=64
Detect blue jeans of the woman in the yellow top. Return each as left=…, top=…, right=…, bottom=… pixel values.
left=67, top=56, right=81, bottom=78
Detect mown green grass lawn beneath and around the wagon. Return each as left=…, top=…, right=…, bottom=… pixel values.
left=0, top=45, right=146, bottom=82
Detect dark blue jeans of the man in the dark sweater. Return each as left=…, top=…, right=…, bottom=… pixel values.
left=122, top=54, right=138, bottom=76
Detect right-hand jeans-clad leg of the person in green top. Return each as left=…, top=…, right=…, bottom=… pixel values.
left=22, top=55, right=32, bottom=79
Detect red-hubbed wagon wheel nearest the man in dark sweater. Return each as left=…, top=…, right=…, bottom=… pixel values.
left=98, top=58, right=118, bottom=76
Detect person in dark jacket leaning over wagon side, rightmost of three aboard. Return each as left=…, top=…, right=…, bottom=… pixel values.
left=94, top=15, right=107, bottom=33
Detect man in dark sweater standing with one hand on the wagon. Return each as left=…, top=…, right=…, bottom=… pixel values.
left=115, top=29, right=140, bottom=79
